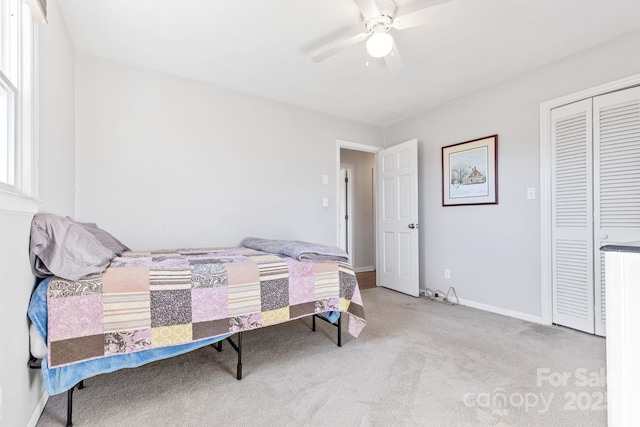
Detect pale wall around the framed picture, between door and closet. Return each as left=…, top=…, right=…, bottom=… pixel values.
left=386, top=32, right=640, bottom=320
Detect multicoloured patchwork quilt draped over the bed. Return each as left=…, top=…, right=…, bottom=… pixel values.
left=47, top=248, right=366, bottom=368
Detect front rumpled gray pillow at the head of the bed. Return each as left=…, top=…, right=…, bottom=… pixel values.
left=29, top=214, right=115, bottom=280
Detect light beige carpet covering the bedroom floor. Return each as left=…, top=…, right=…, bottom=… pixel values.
left=37, top=288, right=607, bottom=427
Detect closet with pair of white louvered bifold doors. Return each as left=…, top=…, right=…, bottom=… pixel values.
left=551, top=87, right=640, bottom=336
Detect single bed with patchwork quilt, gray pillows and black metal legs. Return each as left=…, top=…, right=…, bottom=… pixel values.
left=28, top=214, right=366, bottom=425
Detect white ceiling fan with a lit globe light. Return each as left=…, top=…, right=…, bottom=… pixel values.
left=311, top=0, right=451, bottom=72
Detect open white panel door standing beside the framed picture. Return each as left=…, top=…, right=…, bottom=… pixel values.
left=377, top=139, right=419, bottom=297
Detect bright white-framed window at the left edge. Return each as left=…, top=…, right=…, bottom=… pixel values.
left=0, top=0, right=35, bottom=196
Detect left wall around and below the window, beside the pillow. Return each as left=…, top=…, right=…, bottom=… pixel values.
left=0, top=0, right=74, bottom=426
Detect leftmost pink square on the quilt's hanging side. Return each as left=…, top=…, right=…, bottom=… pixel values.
left=48, top=295, right=104, bottom=341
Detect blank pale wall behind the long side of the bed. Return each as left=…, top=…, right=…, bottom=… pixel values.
left=76, top=56, right=383, bottom=249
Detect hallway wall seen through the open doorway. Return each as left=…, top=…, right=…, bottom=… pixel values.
left=340, top=148, right=376, bottom=270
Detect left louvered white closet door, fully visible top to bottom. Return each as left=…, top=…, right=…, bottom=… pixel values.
left=551, top=99, right=594, bottom=333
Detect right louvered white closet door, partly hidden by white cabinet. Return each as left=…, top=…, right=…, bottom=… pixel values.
left=593, top=87, right=640, bottom=336
